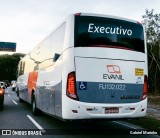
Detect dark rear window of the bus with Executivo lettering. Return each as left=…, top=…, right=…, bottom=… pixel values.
left=74, top=16, right=145, bottom=53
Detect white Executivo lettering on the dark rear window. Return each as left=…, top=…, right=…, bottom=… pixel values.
left=88, top=23, right=132, bottom=36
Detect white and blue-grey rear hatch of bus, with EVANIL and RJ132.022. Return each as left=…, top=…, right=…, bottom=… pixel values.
left=75, top=57, right=145, bottom=103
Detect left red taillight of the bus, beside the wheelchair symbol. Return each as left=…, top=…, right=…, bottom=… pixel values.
left=67, top=72, right=78, bottom=100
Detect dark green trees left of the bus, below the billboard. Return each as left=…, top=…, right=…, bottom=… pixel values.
left=0, top=53, right=24, bottom=81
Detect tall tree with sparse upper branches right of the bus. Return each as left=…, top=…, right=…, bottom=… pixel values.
left=142, top=9, right=160, bottom=95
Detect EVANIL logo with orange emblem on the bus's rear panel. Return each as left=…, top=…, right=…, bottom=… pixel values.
left=103, top=65, right=124, bottom=80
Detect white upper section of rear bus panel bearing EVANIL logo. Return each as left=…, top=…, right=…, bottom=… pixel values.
left=75, top=57, right=145, bottom=84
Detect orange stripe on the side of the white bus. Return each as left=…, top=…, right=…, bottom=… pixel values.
left=28, top=72, right=38, bottom=93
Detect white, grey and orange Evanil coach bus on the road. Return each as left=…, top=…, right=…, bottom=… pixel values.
left=16, top=13, right=148, bottom=120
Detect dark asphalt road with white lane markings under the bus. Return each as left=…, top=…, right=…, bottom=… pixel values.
left=0, top=88, right=158, bottom=138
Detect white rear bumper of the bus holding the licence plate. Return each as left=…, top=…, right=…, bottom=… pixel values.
left=62, top=95, right=147, bottom=120
